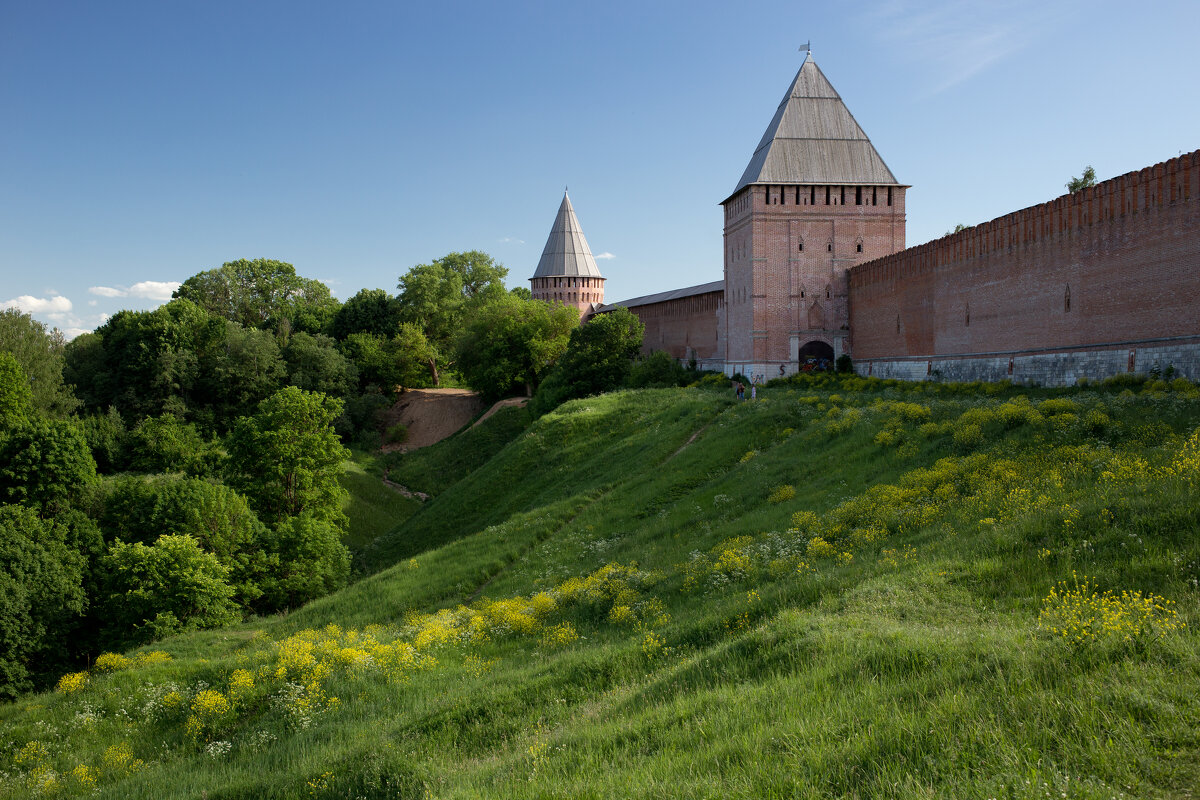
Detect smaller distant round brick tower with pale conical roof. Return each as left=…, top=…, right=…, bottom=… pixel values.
left=529, top=192, right=605, bottom=318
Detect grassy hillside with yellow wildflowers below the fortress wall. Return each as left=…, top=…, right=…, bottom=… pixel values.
left=0, top=381, right=1200, bottom=800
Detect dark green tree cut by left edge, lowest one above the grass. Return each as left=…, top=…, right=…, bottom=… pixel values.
left=0, top=505, right=84, bottom=699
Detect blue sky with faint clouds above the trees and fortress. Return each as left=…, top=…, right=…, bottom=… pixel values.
left=0, top=0, right=1200, bottom=336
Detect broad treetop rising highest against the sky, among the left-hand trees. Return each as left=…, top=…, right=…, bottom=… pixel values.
left=175, top=258, right=338, bottom=335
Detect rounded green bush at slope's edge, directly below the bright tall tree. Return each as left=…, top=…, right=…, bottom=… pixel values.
left=253, top=513, right=350, bottom=609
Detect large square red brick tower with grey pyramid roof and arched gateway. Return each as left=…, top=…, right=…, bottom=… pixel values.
left=715, top=53, right=907, bottom=378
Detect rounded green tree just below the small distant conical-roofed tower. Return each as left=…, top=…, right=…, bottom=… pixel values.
left=455, top=293, right=580, bottom=401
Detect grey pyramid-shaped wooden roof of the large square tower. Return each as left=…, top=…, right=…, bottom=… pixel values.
left=731, top=53, right=900, bottom=197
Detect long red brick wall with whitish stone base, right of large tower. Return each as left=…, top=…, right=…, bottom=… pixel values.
left=848, top=150, right=1200, bottom=385
